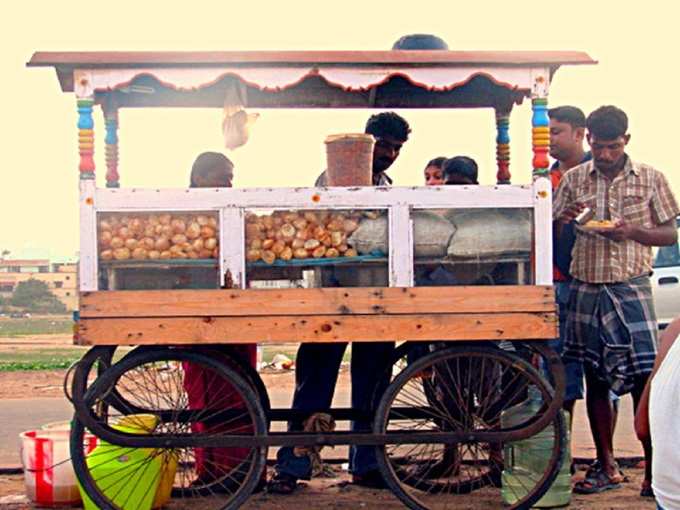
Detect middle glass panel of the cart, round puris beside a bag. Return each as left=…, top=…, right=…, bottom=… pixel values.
left=245, top=206, right=388, bottom=288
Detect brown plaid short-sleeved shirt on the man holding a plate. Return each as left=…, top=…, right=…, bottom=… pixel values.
left=553, top=157, right=678, bottom=283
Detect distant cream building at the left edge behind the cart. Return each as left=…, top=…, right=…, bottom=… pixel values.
left=0, top=259, right=78, bottom=311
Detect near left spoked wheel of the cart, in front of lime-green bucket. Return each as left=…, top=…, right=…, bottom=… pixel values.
left=71, top=348, right=267, bottom=509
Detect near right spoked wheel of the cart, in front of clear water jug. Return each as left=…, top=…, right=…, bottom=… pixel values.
left=373, top=344, right=566, bottom=510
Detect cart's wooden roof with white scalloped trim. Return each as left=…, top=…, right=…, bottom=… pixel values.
left=28, top=50, right=596, bottom=108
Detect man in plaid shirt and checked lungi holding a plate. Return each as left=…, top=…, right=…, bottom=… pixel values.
left=553, top=106, right=678, bottom=496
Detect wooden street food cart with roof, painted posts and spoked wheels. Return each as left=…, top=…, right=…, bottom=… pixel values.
left=28, top=51, right=594, bottom=509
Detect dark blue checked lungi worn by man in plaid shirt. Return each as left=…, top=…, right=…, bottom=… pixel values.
left=563, top=276, right=657, bottom=395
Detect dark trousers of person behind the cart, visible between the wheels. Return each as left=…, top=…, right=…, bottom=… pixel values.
left=276, top=342, right=394, bottom=480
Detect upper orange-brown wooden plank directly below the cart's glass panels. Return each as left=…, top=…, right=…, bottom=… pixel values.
left=80, top=285, right=555, bottom=318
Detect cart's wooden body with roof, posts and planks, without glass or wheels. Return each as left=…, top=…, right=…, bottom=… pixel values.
left=28, top=51, right=596, bottom=350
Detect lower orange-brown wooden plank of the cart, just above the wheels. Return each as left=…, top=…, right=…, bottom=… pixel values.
left=79, top=313, right=557, bottom=345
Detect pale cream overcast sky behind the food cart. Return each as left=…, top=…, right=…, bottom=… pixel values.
left=0, top=0, right=680, bottom=258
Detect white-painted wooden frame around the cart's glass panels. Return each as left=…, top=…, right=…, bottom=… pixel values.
left=81, top=183, right=552, bottom=291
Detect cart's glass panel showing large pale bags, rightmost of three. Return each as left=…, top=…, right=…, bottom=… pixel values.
left=411, top=208, right=533, bottom=286
